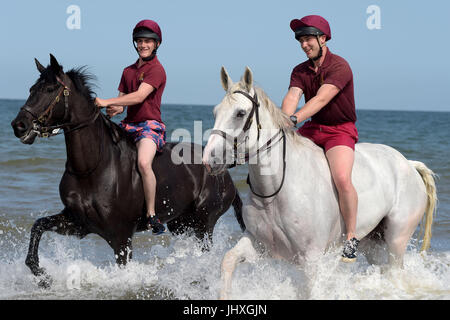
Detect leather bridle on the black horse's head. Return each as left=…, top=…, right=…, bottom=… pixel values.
left=21, top=77, right=100, bottom=138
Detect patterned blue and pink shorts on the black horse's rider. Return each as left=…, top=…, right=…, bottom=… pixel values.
left=119, top=120, right=166, bottom=151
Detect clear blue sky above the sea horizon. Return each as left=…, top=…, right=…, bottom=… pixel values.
left=0, top=0, right=450, bottom=111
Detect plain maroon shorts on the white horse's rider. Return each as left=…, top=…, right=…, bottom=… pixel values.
left=297, top=121, right=358, bottom=152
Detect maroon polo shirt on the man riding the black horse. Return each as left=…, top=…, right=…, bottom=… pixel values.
left=119, top=57, right=166, bottom=123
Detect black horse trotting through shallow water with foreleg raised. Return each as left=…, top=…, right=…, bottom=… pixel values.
left=11, top=55, right=243, bottom=285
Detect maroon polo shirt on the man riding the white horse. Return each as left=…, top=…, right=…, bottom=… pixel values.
left=289, top=49, right=356, bottom=125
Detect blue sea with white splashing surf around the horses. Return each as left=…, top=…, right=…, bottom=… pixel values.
left=0, top=99, right=450, bottom=300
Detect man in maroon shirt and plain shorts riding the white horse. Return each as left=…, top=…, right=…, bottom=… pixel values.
left=282, top=15, right=359, bottom=262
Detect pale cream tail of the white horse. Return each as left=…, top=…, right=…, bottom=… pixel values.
left=409, top=160, right=438, bottom=251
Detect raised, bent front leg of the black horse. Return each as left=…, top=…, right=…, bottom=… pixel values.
left=25, top=209, right=87, bottom=286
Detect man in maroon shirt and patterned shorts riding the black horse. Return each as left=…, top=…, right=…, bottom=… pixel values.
left=95, top=20, right=166, bottom=234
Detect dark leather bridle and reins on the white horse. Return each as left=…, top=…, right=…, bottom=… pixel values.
left=211, top=90, right=286, bottom=198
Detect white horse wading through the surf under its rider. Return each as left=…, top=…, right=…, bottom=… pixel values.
left=203, top=68, right=437, bottom=299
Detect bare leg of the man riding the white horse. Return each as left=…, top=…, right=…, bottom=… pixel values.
left=326, top=146, right=358, bottom=240
